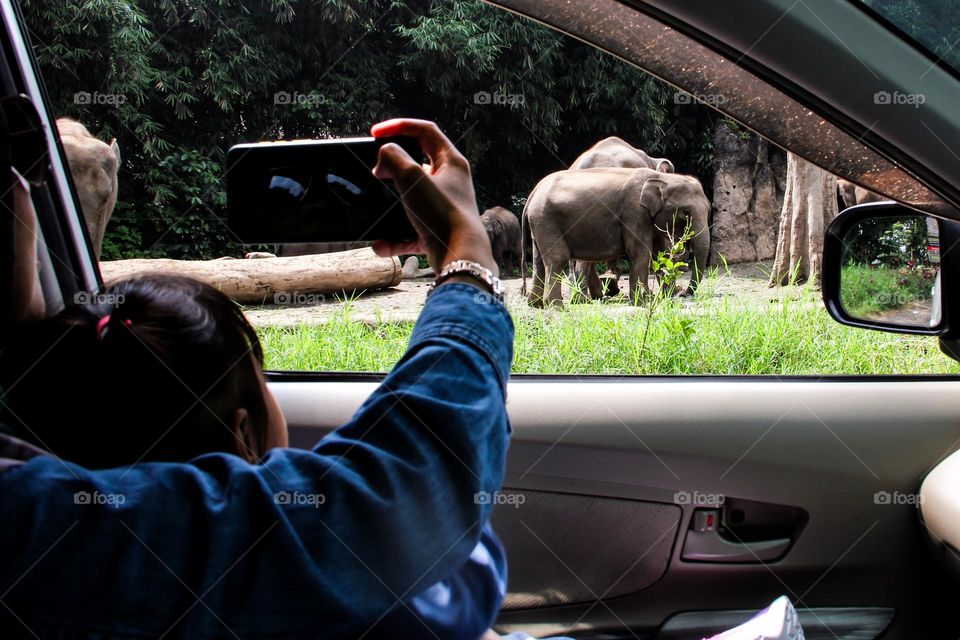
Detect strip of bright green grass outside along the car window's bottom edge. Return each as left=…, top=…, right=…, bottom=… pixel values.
left=258, top=286, right=960, bottom=375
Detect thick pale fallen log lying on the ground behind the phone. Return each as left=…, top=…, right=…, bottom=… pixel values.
left=100, top=248, right=402, bottom=304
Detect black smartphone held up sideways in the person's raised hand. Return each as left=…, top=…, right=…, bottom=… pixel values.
left=227, top=136, right=423, bottom=244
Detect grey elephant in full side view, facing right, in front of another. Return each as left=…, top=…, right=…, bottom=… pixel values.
left=521, top=168, right=710, bottom=306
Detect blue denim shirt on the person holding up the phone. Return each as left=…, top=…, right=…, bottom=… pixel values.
left=0, top=283, right=513, bottom=638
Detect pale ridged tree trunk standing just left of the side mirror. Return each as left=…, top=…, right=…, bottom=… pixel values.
left=770, top=153, right=837, bottom=287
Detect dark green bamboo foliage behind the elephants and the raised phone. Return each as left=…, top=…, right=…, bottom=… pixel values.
left=22, top=0, right=713, bottom=257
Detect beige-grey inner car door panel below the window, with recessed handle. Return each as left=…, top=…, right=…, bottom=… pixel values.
left=271, top=376, right=960, bottom=638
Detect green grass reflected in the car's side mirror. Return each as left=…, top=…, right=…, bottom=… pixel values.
left=841, top=265, right=933, bottom=318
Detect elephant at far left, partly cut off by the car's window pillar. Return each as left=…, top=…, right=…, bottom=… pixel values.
left=57, top=118, right=120, bottom=258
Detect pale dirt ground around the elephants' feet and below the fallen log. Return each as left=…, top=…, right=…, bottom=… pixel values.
left=247, top=262, right=799, bottom=326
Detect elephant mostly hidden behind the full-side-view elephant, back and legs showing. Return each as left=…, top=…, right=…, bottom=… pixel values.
left=570, top=136, right=675, bottom=300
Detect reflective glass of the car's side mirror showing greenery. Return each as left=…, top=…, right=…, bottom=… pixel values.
left=840, top=214, right=940, bottom=328
